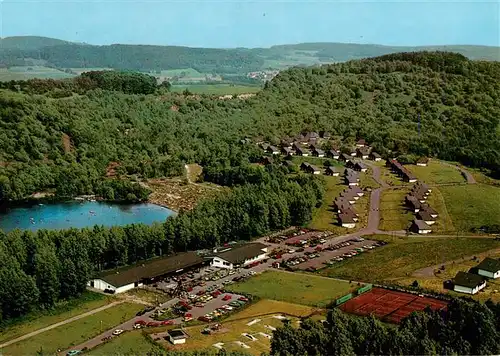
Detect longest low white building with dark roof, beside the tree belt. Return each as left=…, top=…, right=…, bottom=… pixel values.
left=87, top=252, right=204, bottom=293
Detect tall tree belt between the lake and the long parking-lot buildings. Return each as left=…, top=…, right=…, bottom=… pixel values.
left=0, top=167, right=323, bottom=324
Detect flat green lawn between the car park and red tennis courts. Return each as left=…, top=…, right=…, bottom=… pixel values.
left=230, top=271, right=356, bottom=308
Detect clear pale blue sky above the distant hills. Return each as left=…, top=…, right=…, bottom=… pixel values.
left=0, top=0, right=500, bottom=48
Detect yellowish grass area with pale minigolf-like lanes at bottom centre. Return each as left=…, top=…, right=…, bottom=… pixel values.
left=158, top=300, right=312, bottom=355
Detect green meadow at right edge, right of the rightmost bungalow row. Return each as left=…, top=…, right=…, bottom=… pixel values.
left=440, top=184, right=500, bottom=232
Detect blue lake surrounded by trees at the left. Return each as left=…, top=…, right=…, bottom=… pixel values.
left=0, top=201, right=175, bottom=232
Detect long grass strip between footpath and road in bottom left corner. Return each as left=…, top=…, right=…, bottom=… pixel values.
left=1, top=303, right=144, bottom=355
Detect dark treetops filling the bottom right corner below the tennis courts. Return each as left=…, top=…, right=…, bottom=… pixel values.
left=271, top=299, right=500, bottom=356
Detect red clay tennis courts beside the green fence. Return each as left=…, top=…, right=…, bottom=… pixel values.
left=340, top=288, right=448, bottom=323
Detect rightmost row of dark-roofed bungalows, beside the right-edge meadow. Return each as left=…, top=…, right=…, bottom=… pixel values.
left=405, top=183, right=438, bottom=234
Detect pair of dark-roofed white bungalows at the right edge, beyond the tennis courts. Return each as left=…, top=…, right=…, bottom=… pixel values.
left=453, top=257, right=500, bottom=294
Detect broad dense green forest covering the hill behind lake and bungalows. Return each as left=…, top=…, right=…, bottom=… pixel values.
left=0, top=52, right=500, bottom=201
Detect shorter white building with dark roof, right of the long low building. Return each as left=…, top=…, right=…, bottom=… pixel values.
left=210, top=242, right=268, bottom=269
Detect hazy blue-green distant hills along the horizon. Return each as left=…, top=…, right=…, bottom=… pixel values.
left=0, top=36, right=500, bottom=76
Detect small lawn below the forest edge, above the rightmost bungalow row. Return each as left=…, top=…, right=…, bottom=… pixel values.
left=406, top=160, right=467, bottom=184
